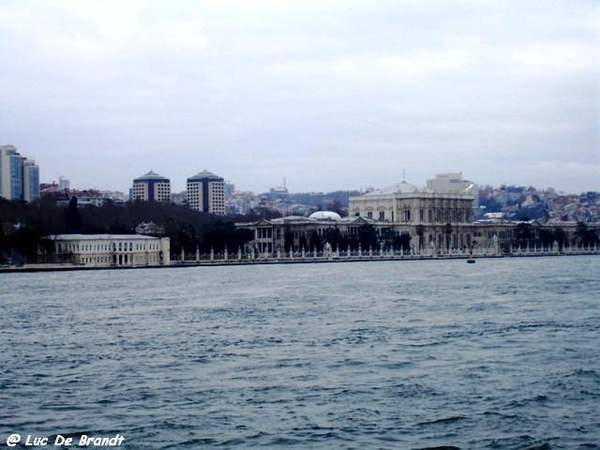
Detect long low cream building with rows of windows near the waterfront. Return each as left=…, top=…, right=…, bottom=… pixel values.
left=47, top=234, right=171, bottom=267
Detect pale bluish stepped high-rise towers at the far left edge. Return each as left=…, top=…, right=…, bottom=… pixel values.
left=0, top=145, right=40, bottom=202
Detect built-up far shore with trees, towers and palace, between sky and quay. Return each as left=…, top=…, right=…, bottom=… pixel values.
left=0, top=146, right=600, bottom=264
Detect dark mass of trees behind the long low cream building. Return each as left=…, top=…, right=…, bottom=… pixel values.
left=0, top=197, right=254, bottom=263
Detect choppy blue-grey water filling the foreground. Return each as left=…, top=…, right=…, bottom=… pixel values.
left=0, top=256, right=600, bottom=449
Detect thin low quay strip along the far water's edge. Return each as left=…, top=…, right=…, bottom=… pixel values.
left=0, top=251, right=600, bottom=274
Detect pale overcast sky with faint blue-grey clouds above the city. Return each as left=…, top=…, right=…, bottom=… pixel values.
left=0, top=0, right=600, bottom=193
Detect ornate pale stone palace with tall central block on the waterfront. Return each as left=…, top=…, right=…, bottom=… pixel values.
left=236, top=178, right=600, bottom=257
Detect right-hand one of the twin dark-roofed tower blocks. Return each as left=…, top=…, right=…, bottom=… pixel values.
left=187, top=170, right=225, bottom=215
